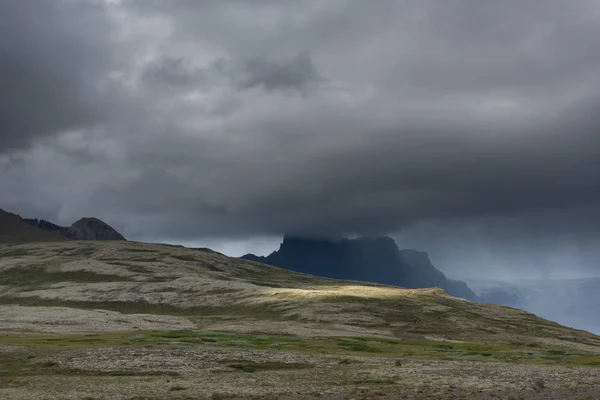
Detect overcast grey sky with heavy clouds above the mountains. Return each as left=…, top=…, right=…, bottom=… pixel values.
left=0, top=0, right=600, bottom=279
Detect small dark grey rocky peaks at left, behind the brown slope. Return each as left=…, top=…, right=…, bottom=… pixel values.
left=23, top=218, right=126, bottom=240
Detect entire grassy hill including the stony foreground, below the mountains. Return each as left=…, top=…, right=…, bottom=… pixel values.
left=0, top=241, right=600, bottom=399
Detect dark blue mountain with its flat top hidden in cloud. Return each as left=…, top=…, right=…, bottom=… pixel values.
left=242, top=236, right=477, bottom=300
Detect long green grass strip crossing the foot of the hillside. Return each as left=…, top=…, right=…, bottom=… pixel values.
left=0, top=331, right=600, bottom=370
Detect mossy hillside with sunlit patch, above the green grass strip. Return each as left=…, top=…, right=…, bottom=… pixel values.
left=0, top=241, right=600, bottom=347
